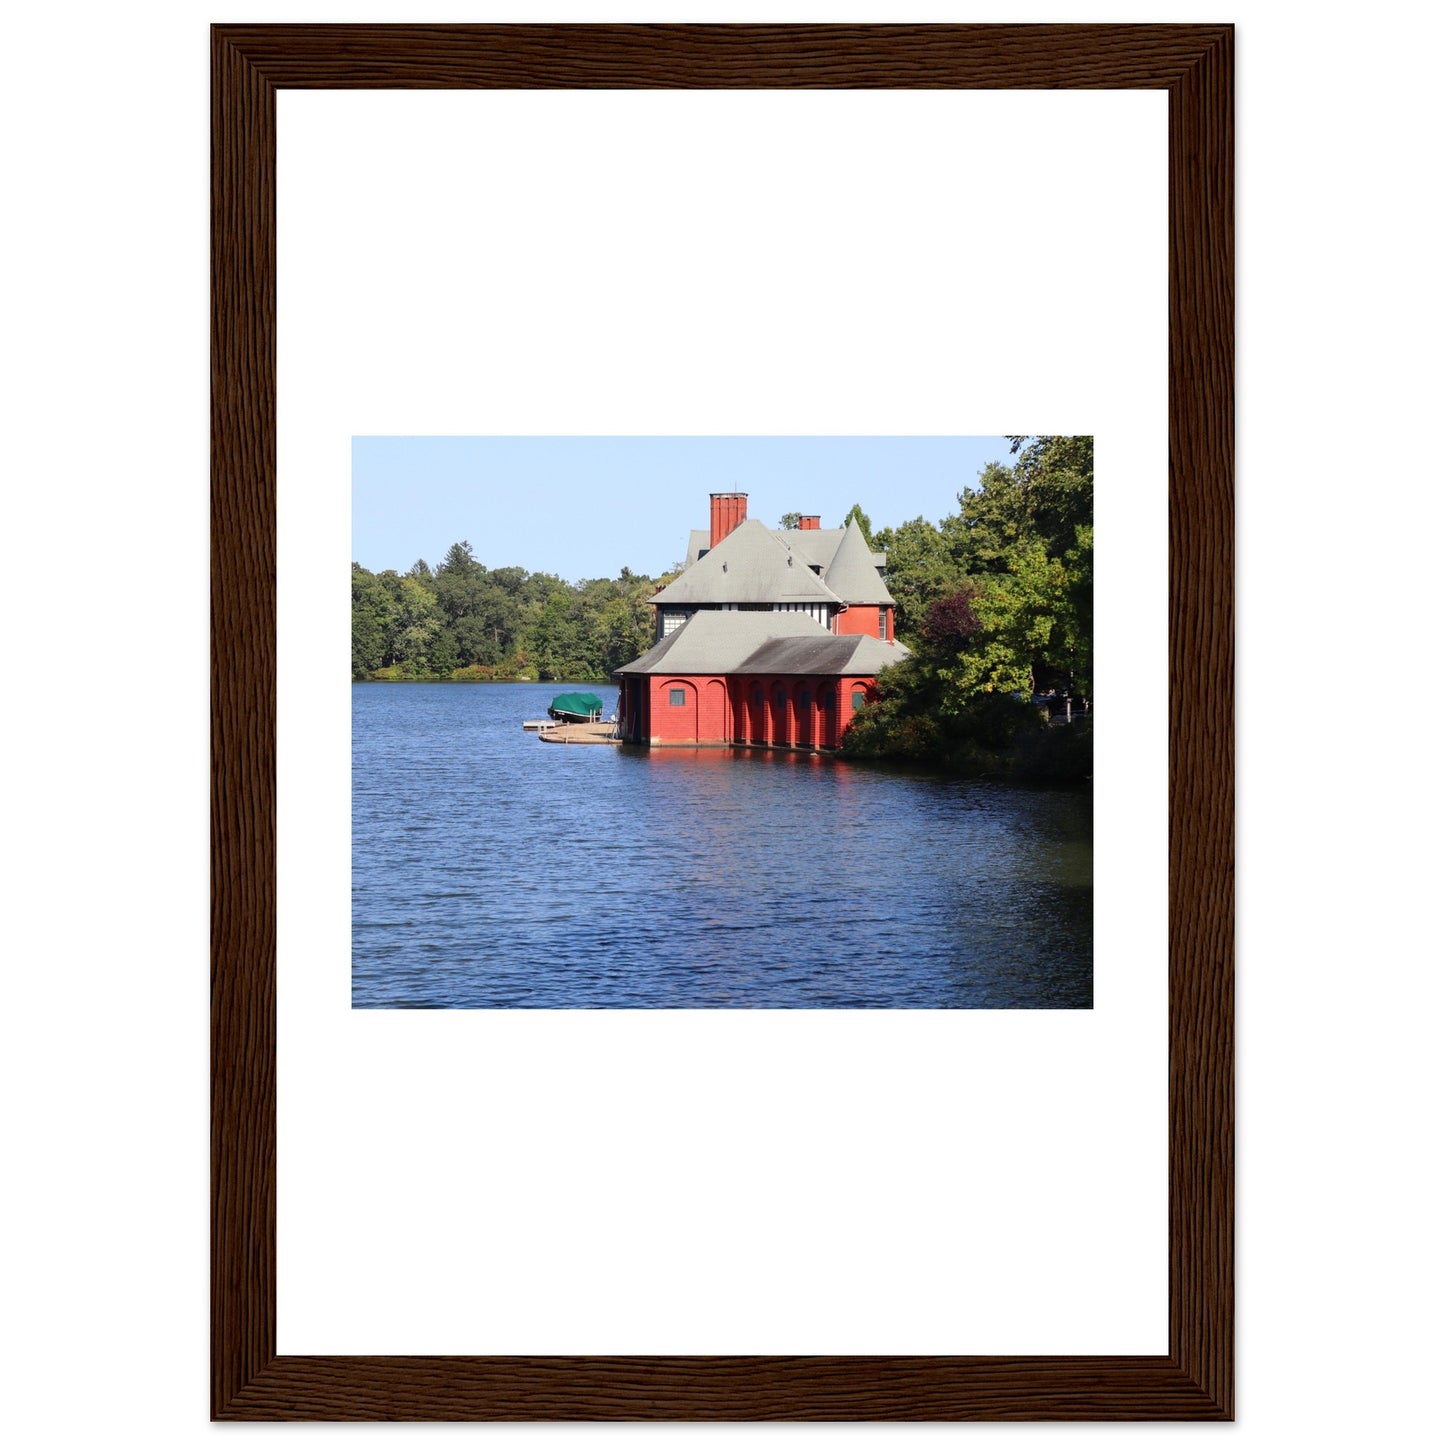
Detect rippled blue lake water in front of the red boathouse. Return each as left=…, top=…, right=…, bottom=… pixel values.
left=351, top=683, right=1092, bottom=1009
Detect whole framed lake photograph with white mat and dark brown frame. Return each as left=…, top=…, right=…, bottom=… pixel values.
left=212, top=25, right=1233, bottom=1420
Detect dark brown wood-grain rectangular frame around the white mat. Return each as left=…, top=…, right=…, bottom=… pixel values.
left=211, top=25, right=1234, bottom=1420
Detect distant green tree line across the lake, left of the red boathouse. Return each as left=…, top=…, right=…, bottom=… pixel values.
left=351, top=542, right=663, bottom=682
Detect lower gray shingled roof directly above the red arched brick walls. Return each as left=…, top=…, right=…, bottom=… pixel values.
left=614, top=613, right=907, bottom=676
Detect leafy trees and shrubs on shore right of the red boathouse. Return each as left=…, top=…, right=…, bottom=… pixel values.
left=844, top=436, right=1094, bottom=779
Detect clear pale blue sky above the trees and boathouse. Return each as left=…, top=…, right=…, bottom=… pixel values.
left=351, top=436, right=1010, bottom=582
